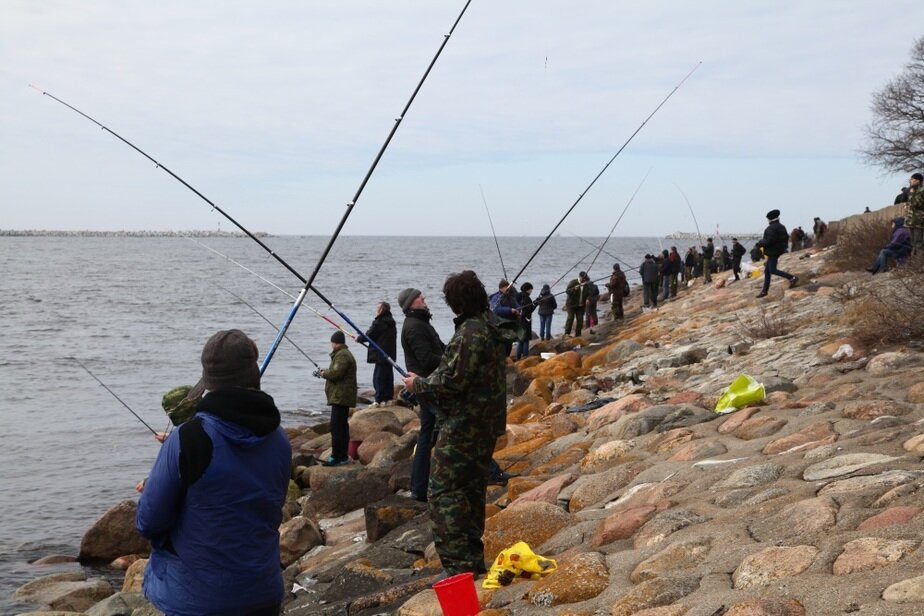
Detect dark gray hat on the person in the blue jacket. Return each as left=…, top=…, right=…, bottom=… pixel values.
left=202, top=329, right=260, bottom=391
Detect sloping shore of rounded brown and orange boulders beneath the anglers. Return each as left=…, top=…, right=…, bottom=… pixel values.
left=17, top=243, right=924, bottom=616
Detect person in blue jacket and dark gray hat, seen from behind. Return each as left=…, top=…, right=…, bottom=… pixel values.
left=135, top=329, right=292, bottom=616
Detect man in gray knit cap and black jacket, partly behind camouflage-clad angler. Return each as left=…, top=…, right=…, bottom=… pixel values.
left=398, top=288, right=445, bottom=502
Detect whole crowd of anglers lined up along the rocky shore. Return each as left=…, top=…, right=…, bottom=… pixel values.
left=130, top=173, right=924, bottom=616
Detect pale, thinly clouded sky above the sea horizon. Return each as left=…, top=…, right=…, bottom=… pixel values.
left=0, top=0, right=924, bottom=237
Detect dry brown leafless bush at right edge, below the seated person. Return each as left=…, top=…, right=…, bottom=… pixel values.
left=843, top=256, right=924, bottom=345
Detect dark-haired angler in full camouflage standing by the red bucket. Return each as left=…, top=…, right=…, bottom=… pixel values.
left=404, top=270, right=516, bottom=575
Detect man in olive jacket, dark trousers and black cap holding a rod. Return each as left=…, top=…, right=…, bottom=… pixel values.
left=319, top=330, right=356, bottom=466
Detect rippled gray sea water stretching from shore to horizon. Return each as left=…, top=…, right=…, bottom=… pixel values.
left=0, top=232, right=686, bottom=614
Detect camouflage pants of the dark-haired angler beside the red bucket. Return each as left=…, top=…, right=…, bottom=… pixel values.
left=428, top=422, right=496, bottom=575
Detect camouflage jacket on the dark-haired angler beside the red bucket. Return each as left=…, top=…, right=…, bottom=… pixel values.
left=414, top=312, right=516, bottom=437
